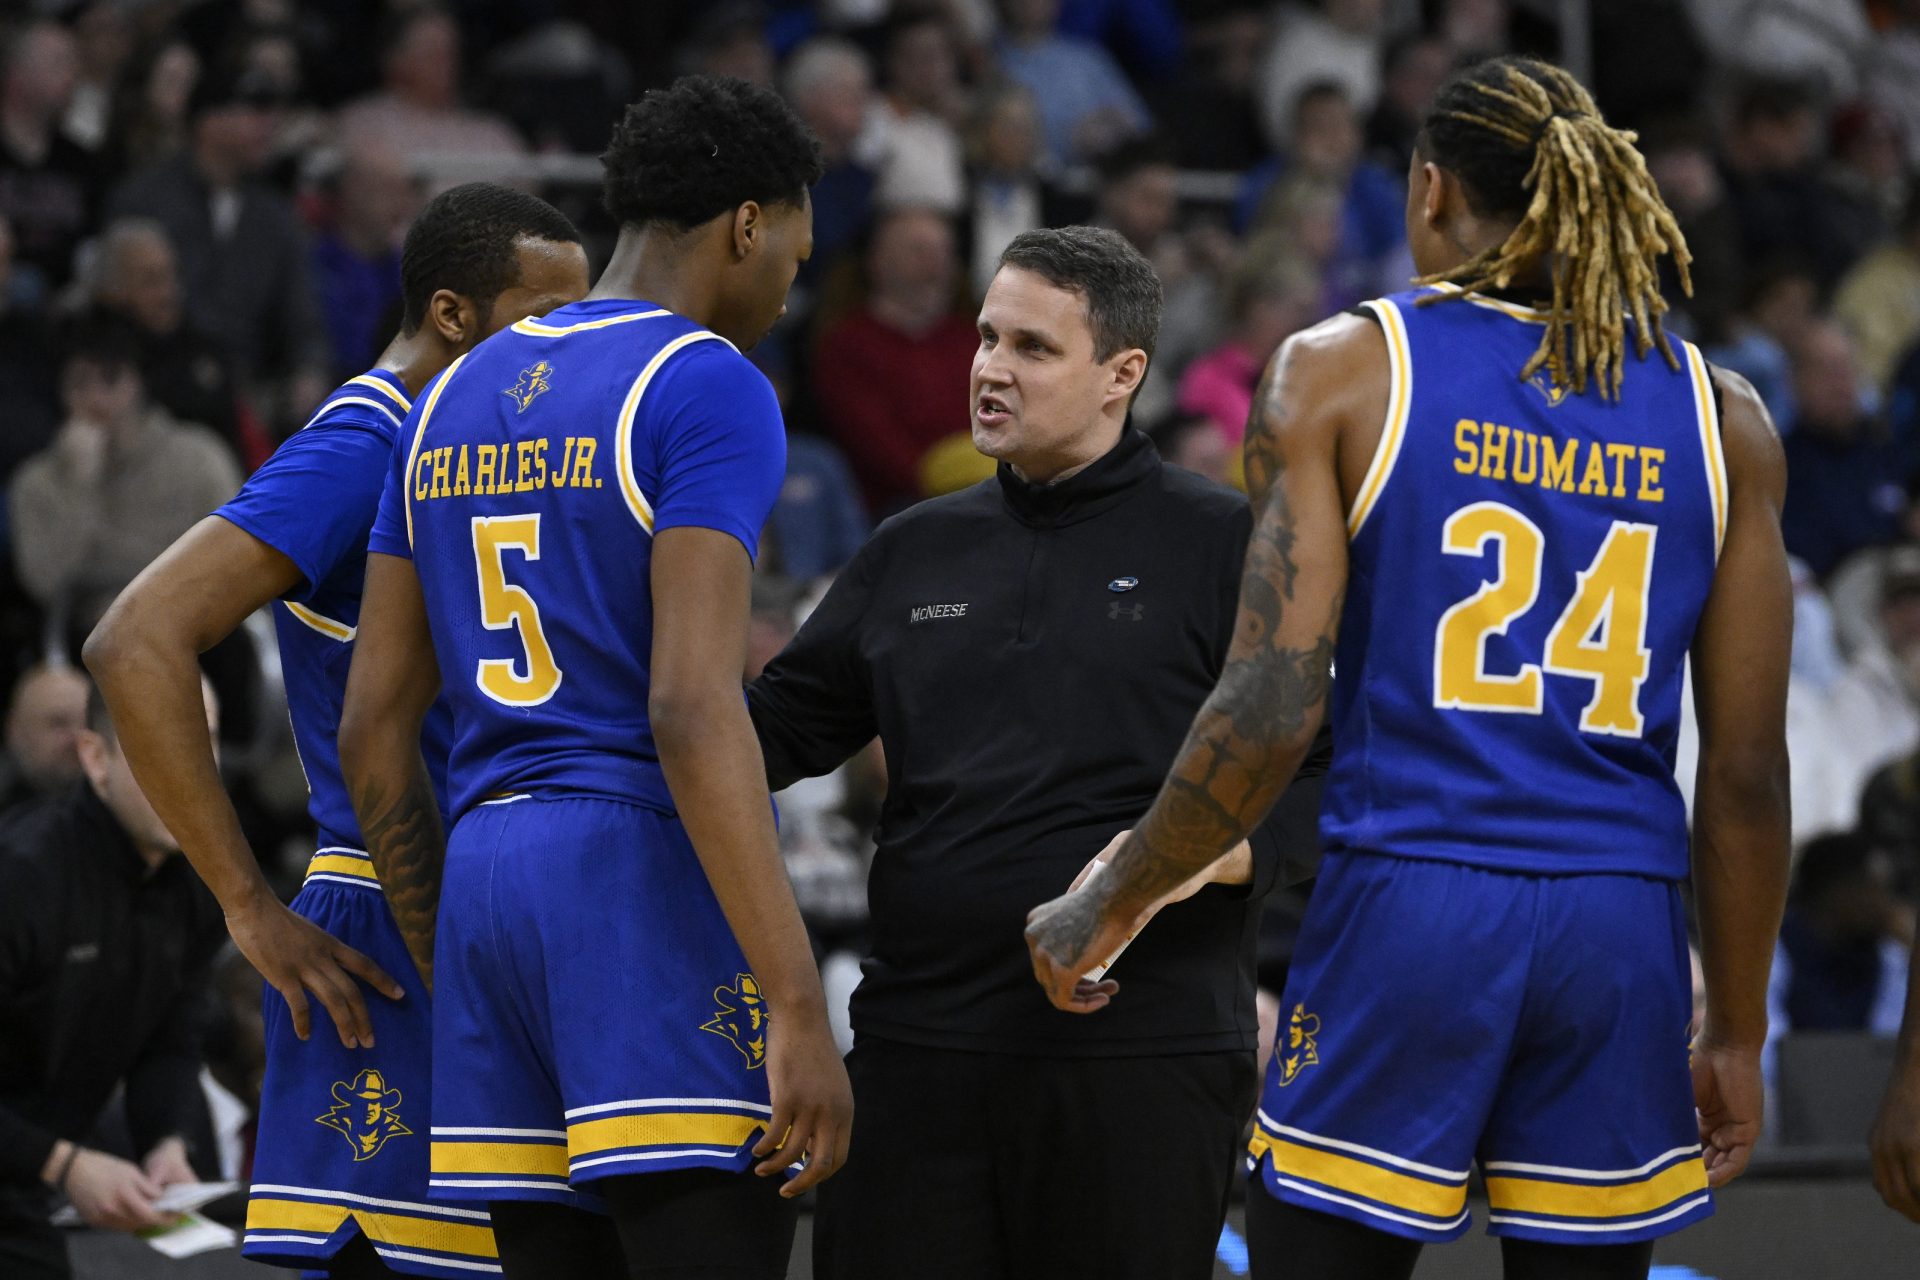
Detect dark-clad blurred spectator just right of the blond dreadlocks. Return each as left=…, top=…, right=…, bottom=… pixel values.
left=1720, top=81, right=1866, bottom=286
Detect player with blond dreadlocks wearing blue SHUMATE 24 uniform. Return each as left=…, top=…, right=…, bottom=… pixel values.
left=1029, top=59, right=1791, bottom=1280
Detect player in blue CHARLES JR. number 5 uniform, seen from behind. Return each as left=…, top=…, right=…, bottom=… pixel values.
left=340, top=77, right=852, bottom=1278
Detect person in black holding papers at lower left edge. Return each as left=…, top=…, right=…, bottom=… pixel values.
left=0, top=679, right=227, bottom=1276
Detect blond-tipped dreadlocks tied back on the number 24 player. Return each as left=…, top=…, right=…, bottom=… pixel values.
left=1419, top=58, right=1693, bottom=399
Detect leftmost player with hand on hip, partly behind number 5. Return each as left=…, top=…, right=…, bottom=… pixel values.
left=86, top=182, right=588, bottom=1278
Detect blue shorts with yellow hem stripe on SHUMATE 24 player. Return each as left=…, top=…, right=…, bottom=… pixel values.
left=1250, top=854, right=1713, bottom=1244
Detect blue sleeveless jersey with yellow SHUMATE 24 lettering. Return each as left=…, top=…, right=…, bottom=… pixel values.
left=1321, top=290, right=1728, bottom=879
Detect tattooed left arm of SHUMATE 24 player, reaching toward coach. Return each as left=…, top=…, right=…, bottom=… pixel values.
left=1027, top=319, right=1384, bottom=1011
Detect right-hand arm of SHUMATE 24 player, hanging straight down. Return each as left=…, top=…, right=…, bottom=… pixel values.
left=1693, top=368, right=1793, bottom=1186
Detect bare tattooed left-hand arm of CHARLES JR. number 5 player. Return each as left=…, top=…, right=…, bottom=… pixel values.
left=340, top=553, right=447, bottom=990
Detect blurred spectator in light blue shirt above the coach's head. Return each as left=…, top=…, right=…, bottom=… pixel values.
left=998, top=0, right=1152, bottom=165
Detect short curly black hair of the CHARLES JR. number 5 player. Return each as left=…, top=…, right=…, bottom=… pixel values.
left=601, top=75, right=820, bottom=230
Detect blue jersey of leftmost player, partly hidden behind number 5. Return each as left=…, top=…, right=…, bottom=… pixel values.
left=215, top=368, right=453, bottom=848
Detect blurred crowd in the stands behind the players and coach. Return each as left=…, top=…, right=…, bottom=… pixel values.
left=0, top=0, right=1920, bottom=1143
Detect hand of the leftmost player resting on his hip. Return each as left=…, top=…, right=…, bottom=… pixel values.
left=227, top=896, right=407, bottom=1050
